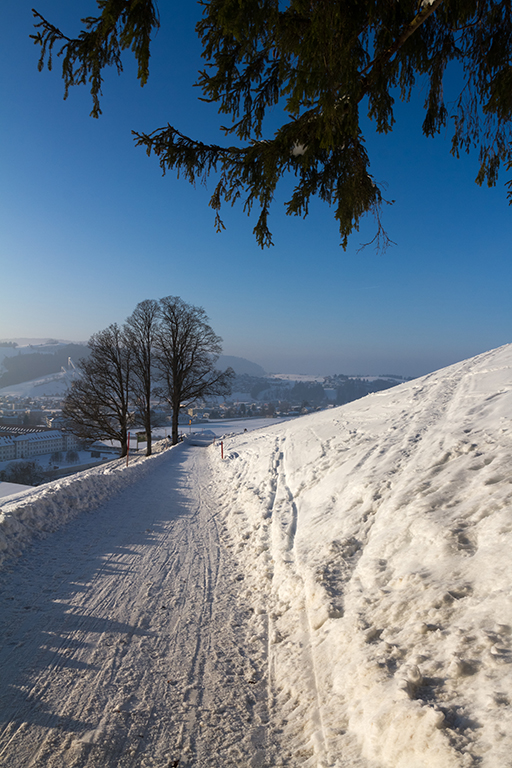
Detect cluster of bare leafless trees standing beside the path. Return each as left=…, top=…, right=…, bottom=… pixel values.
left=62, top=296, right=234, bottom=456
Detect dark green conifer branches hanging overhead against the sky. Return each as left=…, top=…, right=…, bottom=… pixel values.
left=33, top=0, right=512, bottom=247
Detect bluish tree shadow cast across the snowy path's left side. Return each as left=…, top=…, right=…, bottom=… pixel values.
left=0, top=448, right=193, bottom=740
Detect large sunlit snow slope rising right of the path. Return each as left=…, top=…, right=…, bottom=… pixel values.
left=208, top=345, right=512, bottom=768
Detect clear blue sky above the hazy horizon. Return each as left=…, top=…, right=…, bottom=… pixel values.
left=0, top=0, right=512, bottom=376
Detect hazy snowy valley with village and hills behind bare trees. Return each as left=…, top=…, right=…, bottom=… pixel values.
left=0, top=339, right=405, bottom=485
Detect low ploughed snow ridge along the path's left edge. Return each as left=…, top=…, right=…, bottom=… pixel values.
left=0, top=440, right=172, bottom=568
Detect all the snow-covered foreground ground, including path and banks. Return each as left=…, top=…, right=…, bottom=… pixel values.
left=0, top=345, right=512, bottom=768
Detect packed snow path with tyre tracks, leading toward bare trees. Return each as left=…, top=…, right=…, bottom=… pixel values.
left=0, top=447, right=272, bottom=768
